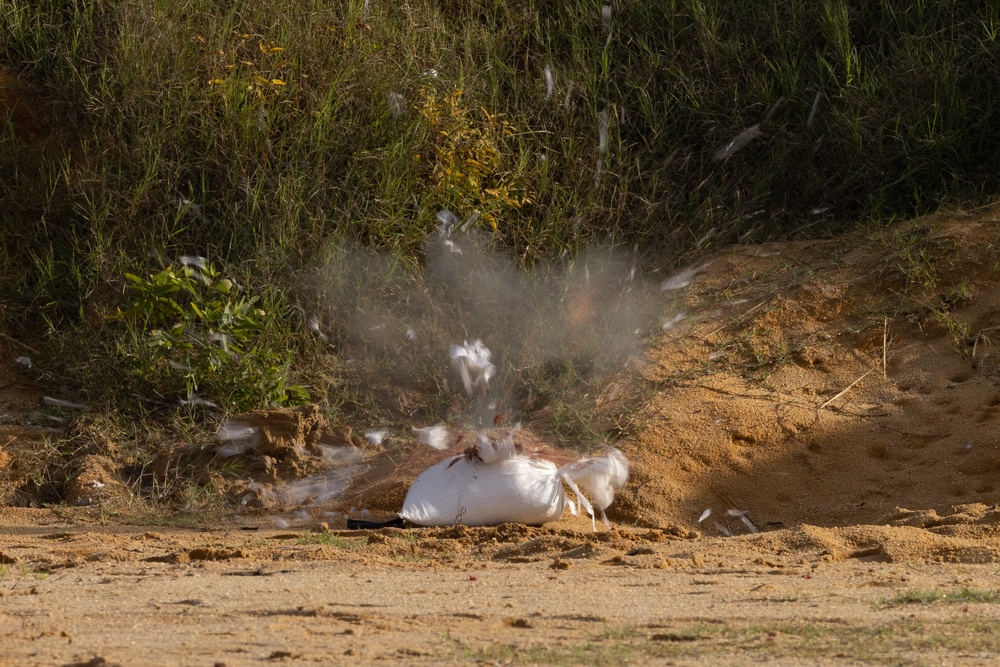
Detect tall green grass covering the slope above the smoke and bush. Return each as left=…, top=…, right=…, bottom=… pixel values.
left=0, top=0, right=1000, bottom=410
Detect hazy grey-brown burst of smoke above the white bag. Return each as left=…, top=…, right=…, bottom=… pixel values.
left=310, top=224, right=660, bottom=422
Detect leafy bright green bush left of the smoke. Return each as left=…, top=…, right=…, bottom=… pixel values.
left=118, top=258, right=308, bottom=411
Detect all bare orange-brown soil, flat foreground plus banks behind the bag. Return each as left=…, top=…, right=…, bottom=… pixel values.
left=0, top=209, right=1000, bottom=665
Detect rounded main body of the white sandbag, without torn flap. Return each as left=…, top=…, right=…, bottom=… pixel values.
left=400, top=455, right=566, bottom=526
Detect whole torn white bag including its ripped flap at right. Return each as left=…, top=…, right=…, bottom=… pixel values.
left=400, top=435, right=628, bottom=526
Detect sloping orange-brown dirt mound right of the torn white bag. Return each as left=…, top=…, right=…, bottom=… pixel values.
left=612, top=214, right=1000, bottom=544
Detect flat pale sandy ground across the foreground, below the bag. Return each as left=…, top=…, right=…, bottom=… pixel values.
left=0, top=510, right=1000, bottom=665
